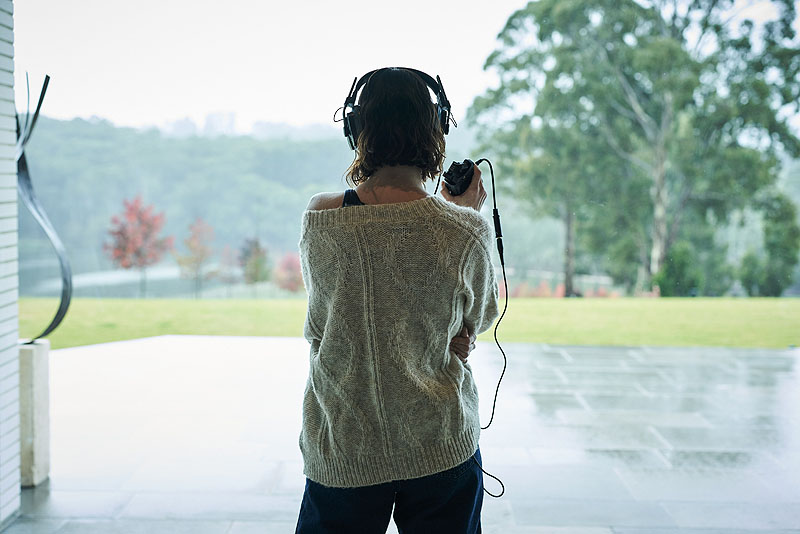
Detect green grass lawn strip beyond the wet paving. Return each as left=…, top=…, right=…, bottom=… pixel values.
left=19, top=298, right=800, bottom=349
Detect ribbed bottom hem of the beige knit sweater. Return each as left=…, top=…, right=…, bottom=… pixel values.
left=303, top=427, right=480, bottom=488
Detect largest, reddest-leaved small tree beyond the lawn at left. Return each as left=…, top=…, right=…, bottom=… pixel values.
left=103, top=195, right=174, bottom=297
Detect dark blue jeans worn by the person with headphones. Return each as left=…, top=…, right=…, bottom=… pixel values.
left=295, top=449, right=483, bottom=534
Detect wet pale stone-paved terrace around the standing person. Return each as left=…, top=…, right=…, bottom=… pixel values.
left=5, top=336, right=800, bottom=534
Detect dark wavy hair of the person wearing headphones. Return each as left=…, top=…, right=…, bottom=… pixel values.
left=346, top=68, right=445, bottom=186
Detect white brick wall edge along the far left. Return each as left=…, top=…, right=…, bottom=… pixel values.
left=0, top=0, right=20, bottom=529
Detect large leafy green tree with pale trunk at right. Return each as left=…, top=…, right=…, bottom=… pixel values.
left=470, top=0, right=800, bottom=294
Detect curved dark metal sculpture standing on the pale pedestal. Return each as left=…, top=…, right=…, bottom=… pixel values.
left=15, top=75, right=72, bottom=344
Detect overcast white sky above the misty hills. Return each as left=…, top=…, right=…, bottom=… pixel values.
left=14, top=0, right=526, bottom=129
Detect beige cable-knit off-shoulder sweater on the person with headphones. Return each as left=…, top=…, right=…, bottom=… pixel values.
left=299, top=196, right=498, bottom=487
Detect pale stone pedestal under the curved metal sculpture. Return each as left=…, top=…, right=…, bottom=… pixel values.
left=19, top=339, right=50, bottom=487
